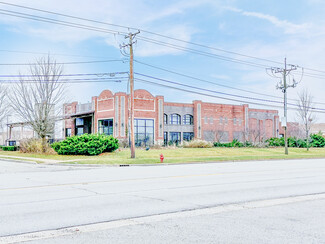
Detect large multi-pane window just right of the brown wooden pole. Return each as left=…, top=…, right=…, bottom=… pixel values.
left=134, top=119, right=154, bottom=146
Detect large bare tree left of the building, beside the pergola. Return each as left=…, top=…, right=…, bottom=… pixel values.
left=10, top=56, right=65, bottom=152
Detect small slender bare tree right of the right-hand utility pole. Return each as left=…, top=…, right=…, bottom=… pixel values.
left=297, top=89, right=316, bottom=151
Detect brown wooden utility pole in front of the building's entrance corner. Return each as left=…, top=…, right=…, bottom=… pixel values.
left=120, top=31, right=140, bottom=158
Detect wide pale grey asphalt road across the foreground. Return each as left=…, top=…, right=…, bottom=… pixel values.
left=0, top=159, right=325, bottom=243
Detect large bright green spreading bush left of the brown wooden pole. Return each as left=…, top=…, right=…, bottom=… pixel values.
left=51, top=134, right=119, bottom=155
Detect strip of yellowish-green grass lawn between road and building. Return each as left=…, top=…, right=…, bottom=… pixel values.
left=0, top=148, right=325, bottom=165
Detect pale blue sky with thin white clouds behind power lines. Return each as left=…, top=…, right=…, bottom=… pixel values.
left=0, top=0, right=325, bottom=122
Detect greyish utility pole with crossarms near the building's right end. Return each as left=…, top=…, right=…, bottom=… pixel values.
left=270, top=58, right=298, bottom=155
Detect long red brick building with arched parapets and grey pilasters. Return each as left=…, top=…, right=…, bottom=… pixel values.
left=64, top=90, right=279, bottom=145
